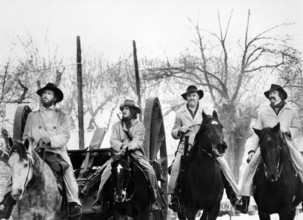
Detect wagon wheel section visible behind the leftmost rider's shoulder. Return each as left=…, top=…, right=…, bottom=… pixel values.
left=13, top=105, right=32, bottom=141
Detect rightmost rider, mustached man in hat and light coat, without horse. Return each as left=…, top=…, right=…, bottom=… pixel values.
left=235, top=84, right=303, bottom=213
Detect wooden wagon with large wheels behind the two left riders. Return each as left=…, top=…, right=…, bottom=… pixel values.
left=13, top=98, right=167, bottom=220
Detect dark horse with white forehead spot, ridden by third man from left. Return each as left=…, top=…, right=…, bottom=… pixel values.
left=178, top=111, right=226, bottom=220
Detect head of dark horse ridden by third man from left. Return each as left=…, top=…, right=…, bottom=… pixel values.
left=196, top=111, right=227, bottom=156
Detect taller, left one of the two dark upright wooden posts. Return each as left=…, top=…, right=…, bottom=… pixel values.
left=77, top=36, right=84, bottom=149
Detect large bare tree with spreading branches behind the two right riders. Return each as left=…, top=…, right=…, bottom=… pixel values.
left=146, top=11, right=300, bottom=180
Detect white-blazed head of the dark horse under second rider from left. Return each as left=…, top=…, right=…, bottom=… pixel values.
left=111, top=149, right=132, bottom=203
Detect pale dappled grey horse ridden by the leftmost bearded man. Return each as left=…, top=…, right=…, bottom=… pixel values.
left=8, top=139, right=67, bottom=220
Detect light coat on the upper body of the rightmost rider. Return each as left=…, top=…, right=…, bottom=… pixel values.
left=249, top=104, right=302, bottom=151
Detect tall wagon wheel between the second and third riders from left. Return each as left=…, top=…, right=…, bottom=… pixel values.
left=143, top=98, right=167, bottom=219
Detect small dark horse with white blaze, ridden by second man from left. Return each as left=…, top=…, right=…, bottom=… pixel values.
left=108, top=150, right=150, bottom=220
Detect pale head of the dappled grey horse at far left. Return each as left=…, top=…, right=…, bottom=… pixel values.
left=8, top=138, right=34, bottom=200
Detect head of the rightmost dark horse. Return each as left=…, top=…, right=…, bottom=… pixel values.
left=254, top=123, right=287, bottom=182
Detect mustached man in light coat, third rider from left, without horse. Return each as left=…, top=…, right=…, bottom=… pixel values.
left=168, top=85, right=239, bottom=212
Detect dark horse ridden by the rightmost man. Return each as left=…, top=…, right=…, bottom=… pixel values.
left=253, top=123, right=303, bottom=220
